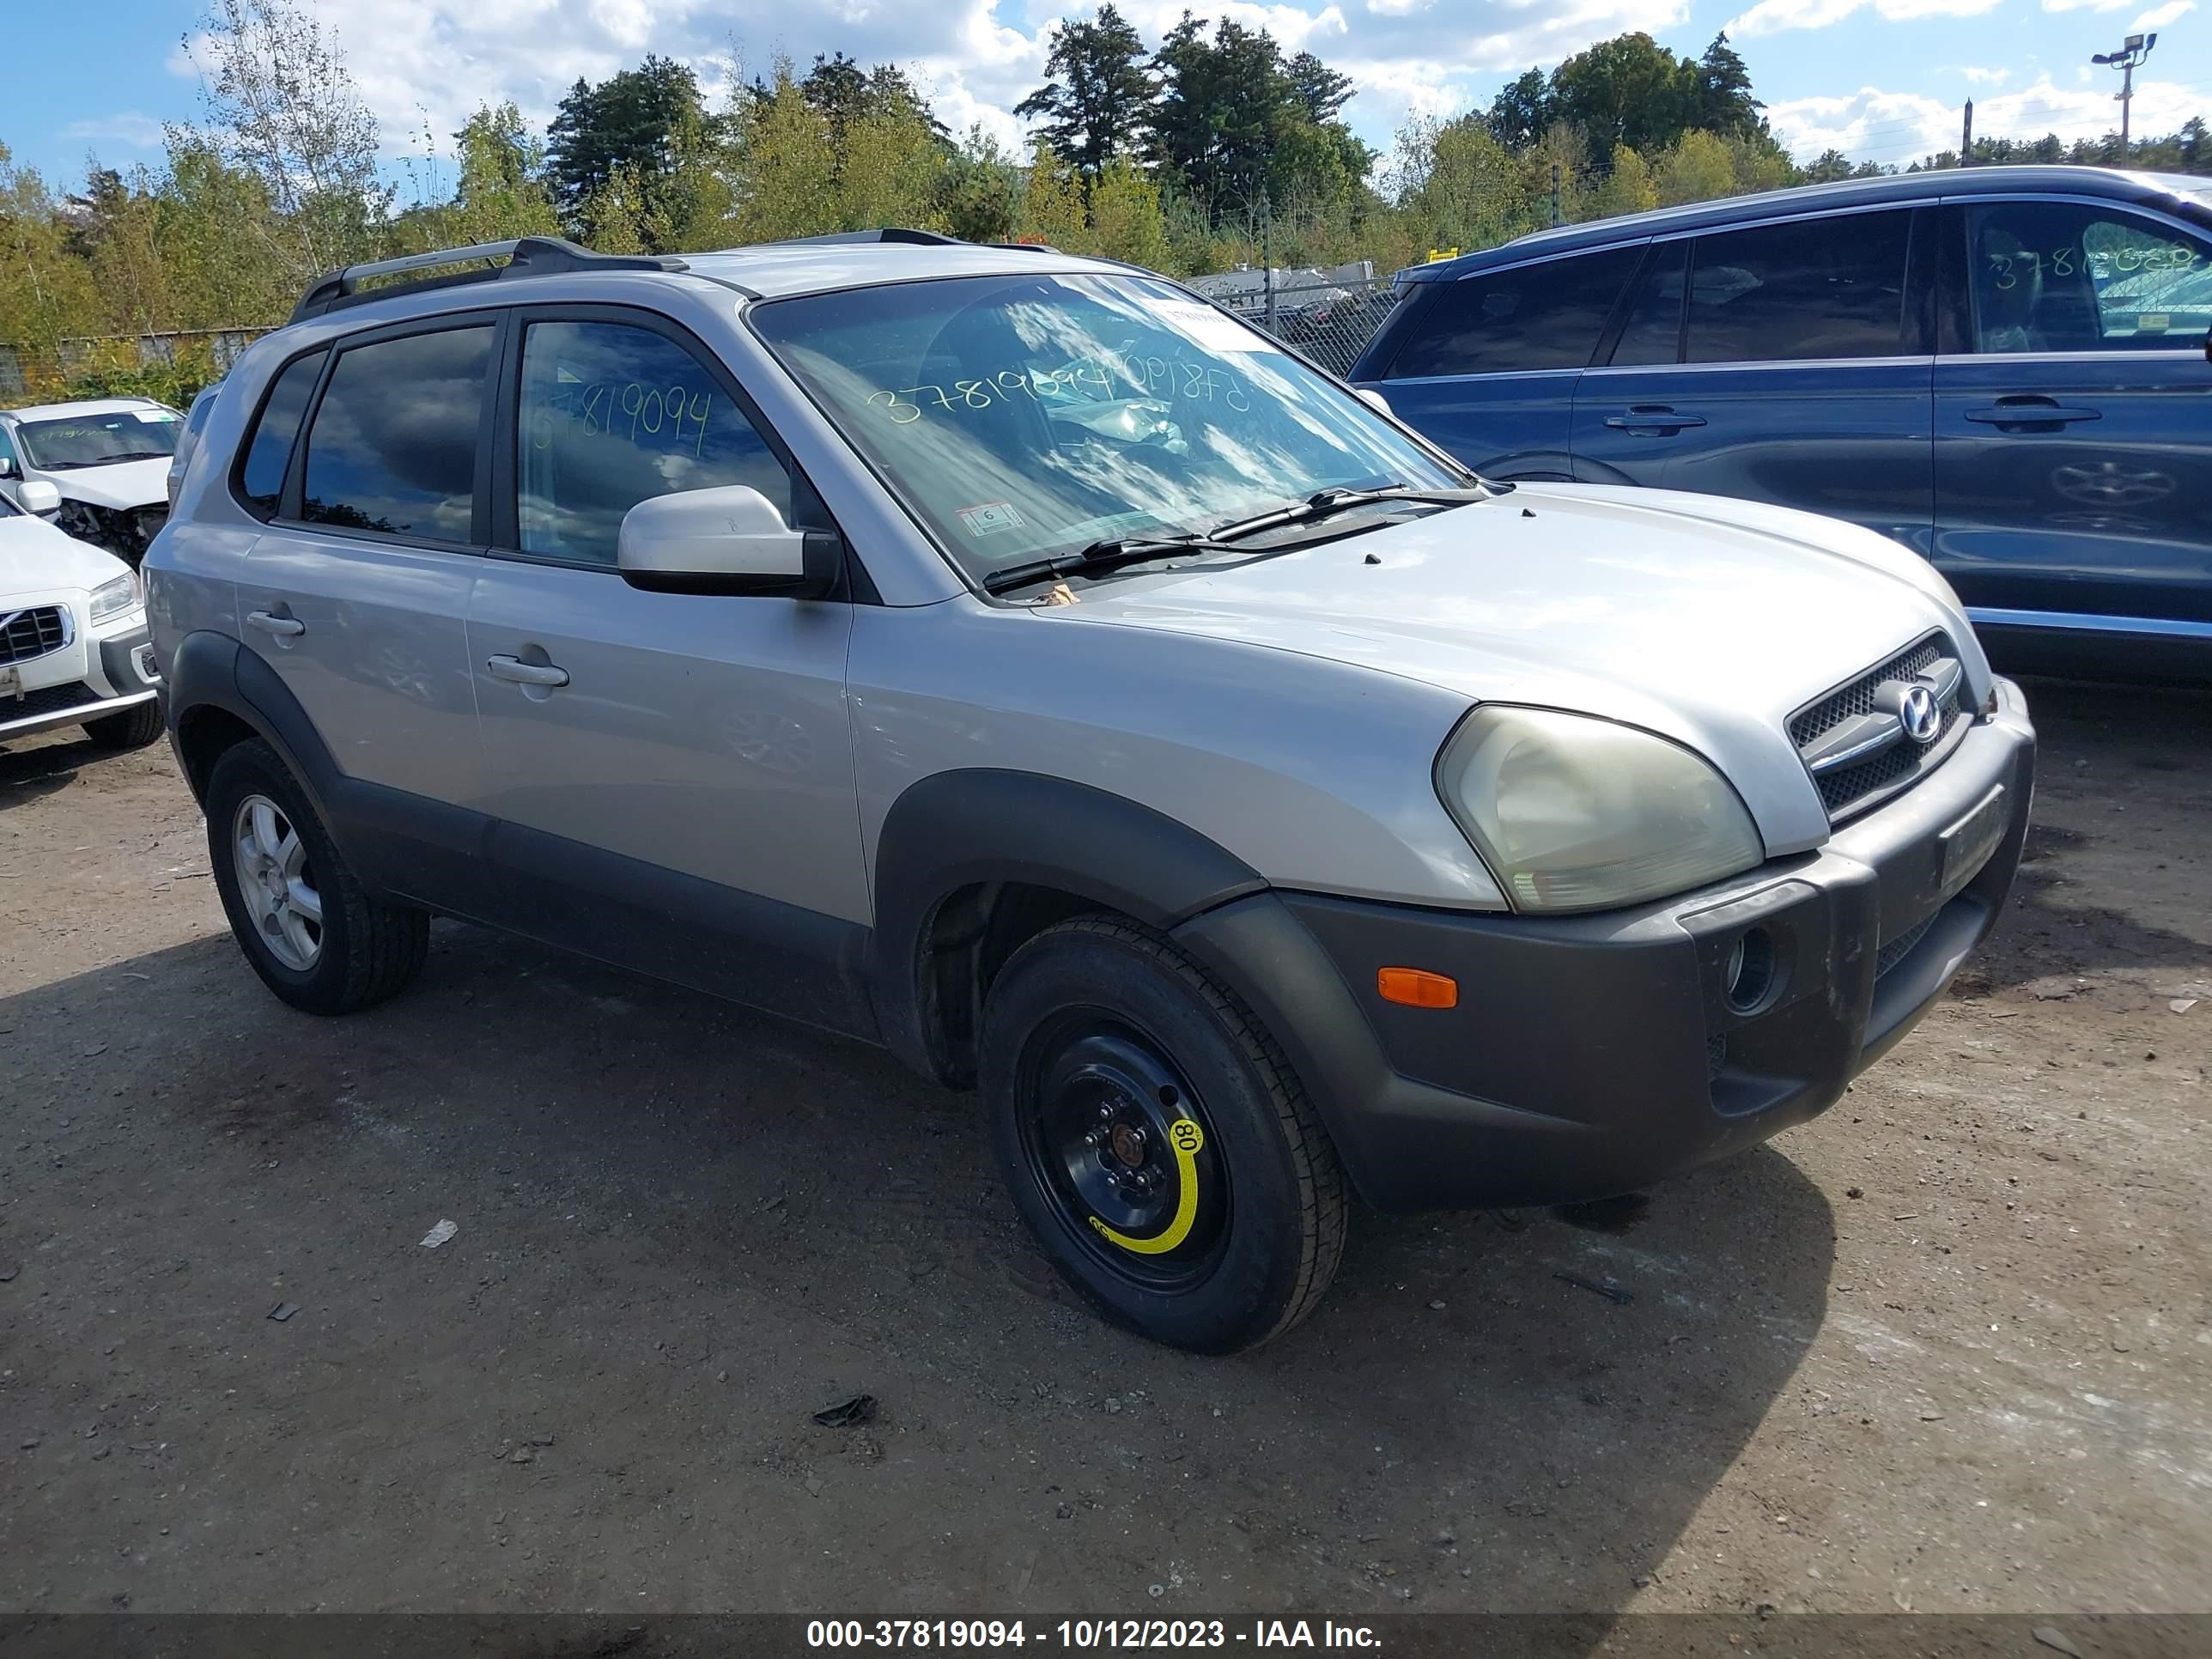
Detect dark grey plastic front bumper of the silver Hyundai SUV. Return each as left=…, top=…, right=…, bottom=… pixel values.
left=1176, top=681, right=2035, bottom=1210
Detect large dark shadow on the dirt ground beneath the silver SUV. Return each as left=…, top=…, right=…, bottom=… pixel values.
left=0, top=925, right=1847, bottom=1632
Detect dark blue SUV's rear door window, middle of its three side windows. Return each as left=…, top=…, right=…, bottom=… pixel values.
left=1683, top=210, right=1913, bottom=362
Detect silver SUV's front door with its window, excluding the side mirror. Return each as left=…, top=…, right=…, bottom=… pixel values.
left=469, top=307, right=869, bottom=1026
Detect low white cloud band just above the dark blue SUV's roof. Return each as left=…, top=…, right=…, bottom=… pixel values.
left=1767, top=76, right=2203, bottom=166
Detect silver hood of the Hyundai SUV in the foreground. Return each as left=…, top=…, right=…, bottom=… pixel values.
left=1037, top=484, right=1989, bottom=852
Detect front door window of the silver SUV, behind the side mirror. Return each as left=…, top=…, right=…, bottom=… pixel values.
left=515, top=323, right=794, bottom=564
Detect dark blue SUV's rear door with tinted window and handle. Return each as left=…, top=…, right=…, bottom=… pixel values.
left=1573, top=208, right=1933, bottom=553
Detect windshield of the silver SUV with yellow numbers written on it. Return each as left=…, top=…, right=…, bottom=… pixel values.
left=752, top=276, right=1468, bottom=581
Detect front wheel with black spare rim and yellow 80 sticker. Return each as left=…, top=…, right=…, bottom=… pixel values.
left=982, top=918, right=1345, bottom=1354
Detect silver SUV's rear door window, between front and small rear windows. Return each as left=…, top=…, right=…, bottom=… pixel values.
left=301, top=323, right=491, bottom=542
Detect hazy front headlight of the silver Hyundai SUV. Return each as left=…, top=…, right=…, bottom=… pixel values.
left=1436, top=706, right=1765, bottom=911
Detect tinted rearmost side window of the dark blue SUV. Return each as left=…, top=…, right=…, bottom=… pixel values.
left=1391, top=248, right=1641, bottom=380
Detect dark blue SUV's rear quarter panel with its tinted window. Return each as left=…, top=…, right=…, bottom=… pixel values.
left=1370, top=243, right=1641, bottom=477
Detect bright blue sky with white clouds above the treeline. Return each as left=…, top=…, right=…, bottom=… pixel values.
left=0, top=0, right=2212, bottom=194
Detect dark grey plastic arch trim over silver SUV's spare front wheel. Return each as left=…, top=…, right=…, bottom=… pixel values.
left=869, top=768, right=1267, bottom=1088
